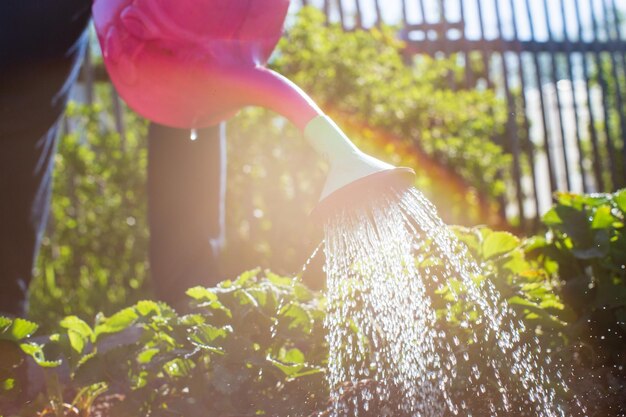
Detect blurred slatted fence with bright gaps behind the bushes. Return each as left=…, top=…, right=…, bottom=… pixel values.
left=300, top=0, right=626, bottom=228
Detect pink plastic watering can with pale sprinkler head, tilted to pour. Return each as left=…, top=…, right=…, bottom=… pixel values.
left=93, top=0, right=414, bottom=211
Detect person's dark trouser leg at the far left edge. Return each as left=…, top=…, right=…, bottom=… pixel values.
left=0, top=0, right=90, bottom=315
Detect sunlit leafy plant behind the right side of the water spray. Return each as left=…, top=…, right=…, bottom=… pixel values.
left=419, top=227, right=571, bottom=415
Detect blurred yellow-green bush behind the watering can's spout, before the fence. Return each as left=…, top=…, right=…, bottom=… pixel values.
left=273, top=9, right=511, bottom=205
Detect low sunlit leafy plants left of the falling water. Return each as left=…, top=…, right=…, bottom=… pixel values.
left=13, top=270, right=327, bottom=417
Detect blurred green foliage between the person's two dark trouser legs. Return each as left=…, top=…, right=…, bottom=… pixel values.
left=29, top=96, right=148, bottom=332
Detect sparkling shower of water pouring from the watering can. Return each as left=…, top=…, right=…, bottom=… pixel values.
left=324, top=188, right=567, bottom=417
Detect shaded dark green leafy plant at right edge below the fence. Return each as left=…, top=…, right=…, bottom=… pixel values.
left=530, top=190, right=626, bottom=369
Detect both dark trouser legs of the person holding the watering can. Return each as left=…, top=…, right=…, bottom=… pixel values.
left=0, top=0, right=225, bottom=315
